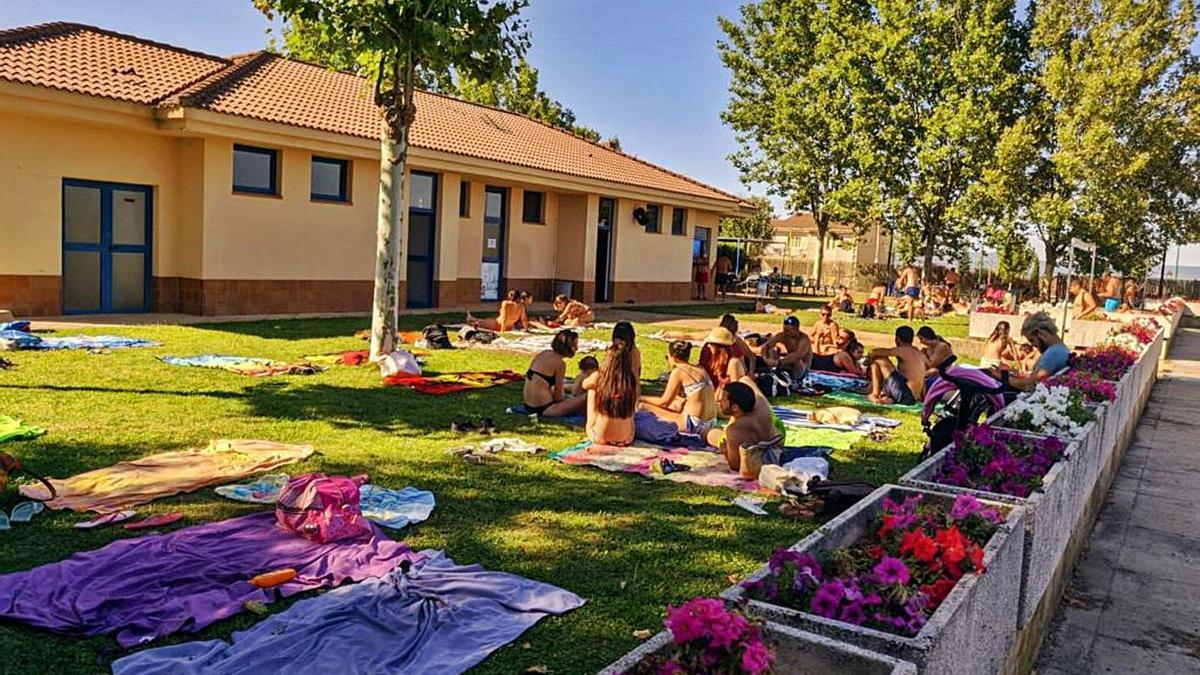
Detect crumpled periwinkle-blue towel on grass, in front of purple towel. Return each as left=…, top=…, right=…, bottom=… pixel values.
left=113, top=550, right=584, bottom=675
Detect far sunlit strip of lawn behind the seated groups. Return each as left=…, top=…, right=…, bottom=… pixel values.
left=622, top=298, right=970, bottom=338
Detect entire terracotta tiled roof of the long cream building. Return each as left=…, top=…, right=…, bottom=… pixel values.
left=0, top=24, right=740, bottom=203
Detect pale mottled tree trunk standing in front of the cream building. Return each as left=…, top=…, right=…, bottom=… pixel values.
left=371, top=120, right=408, bottom=359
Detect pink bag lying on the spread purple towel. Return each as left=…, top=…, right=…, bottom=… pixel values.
left=275, top=473, right=373, bottom=544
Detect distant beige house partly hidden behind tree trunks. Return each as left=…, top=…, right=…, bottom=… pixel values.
left=763, top=211, right=890, bottom=286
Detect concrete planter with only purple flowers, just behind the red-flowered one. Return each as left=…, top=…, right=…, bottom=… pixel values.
left=900, top=426, right=1094, bottom=627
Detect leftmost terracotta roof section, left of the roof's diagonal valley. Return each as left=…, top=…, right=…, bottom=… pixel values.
left=0, top=23, right=229, bottom=103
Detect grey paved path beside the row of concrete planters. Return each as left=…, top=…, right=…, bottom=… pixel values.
left=1037, top=328, right=1200, bottom=675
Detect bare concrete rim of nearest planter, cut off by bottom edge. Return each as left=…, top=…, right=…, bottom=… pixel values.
left=600, top=621, right=917, bottom=675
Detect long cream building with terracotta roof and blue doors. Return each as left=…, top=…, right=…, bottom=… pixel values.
left=0, top=23, right=745, bottom=315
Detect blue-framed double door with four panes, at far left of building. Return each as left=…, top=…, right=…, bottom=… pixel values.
left=62, top=178, right=154, bottom=313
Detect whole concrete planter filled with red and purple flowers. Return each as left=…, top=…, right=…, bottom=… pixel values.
left=724, top=485, right=1025, bottom=674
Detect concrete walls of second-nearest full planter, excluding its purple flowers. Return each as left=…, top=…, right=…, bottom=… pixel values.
left=900, top=430, right=1098, bottom=627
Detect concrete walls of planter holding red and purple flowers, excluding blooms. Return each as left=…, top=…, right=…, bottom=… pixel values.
left=722, top=485, right=1025, bottom=675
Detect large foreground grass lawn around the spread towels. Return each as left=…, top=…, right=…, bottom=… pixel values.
left=0, top=307, right=924, bottom=673
